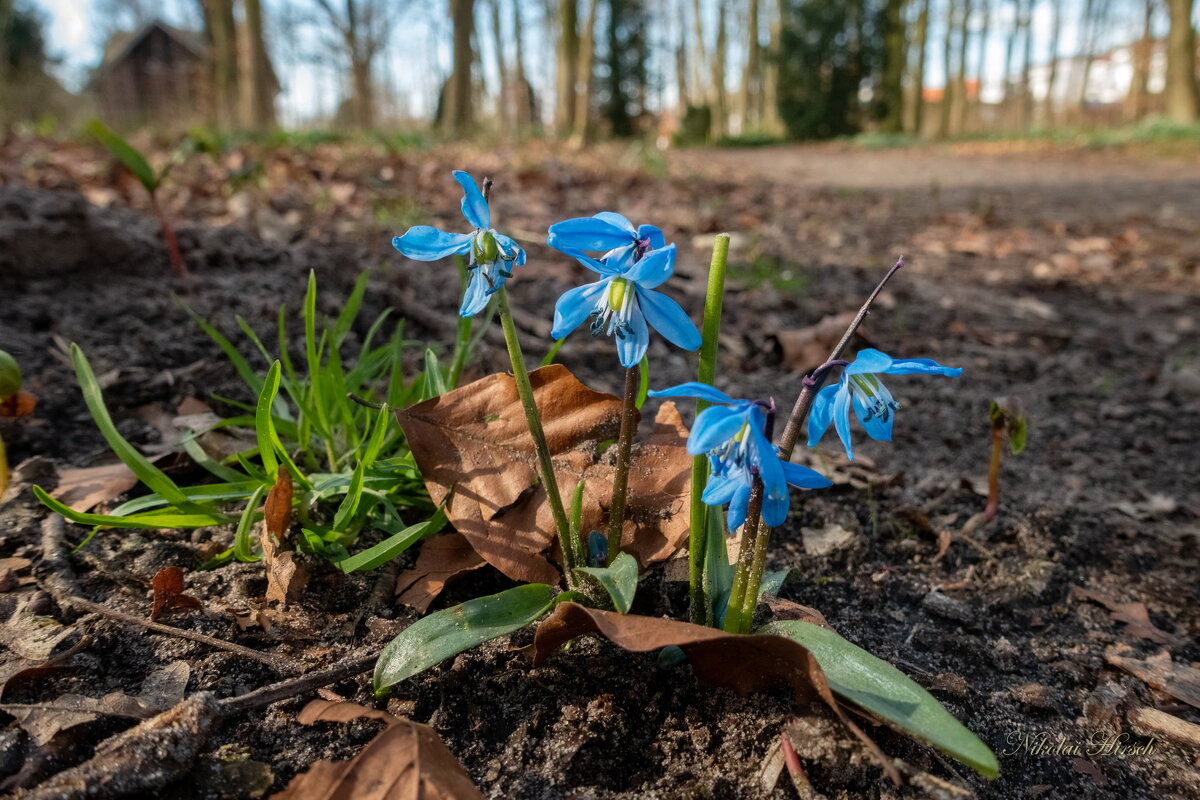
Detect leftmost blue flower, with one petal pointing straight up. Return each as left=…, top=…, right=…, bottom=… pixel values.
left=391, top=170, right=526, bottom=317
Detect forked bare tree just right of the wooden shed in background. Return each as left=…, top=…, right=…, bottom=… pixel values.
left=308, top=0, right=407, bottom=130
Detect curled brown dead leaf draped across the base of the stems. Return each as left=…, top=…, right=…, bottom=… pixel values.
left=533, top=602, right=900, bottom=786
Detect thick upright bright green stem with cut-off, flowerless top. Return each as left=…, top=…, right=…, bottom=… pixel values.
left=688, top=234, right=730, bottom=625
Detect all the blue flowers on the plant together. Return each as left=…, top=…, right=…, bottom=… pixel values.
left=392, top=172, right=962, bottom=530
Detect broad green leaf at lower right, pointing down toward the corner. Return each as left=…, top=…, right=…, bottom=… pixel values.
left=757, top=620, right=1000, bottom=777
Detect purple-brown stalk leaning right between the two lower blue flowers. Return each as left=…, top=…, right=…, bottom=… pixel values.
left=725, top=255, right=904, bottom=633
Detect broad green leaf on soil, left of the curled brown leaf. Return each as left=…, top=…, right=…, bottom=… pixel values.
left=374, top=583, right=554, bottom=693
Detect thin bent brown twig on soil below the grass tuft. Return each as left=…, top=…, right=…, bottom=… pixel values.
left=41, top=515, right=305, bottom=674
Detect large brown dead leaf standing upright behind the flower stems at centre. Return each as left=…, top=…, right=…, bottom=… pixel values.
left=396, top=365, right=691, bottom=583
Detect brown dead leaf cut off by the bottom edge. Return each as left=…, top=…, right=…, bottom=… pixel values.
left=271, top=700, right=484, bottom=800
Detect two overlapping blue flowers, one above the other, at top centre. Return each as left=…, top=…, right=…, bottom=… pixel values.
left=546, top=211, right=701, bottom=367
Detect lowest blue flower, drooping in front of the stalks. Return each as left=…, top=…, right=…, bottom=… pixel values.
left=650, top=381, right=830, bottom=530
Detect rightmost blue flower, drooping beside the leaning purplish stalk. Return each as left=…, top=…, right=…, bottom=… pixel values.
left=809, top=349, right=962, bottom=458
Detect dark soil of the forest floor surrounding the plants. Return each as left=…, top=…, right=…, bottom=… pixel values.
left=0, top=145, right=1200, bottom=800
